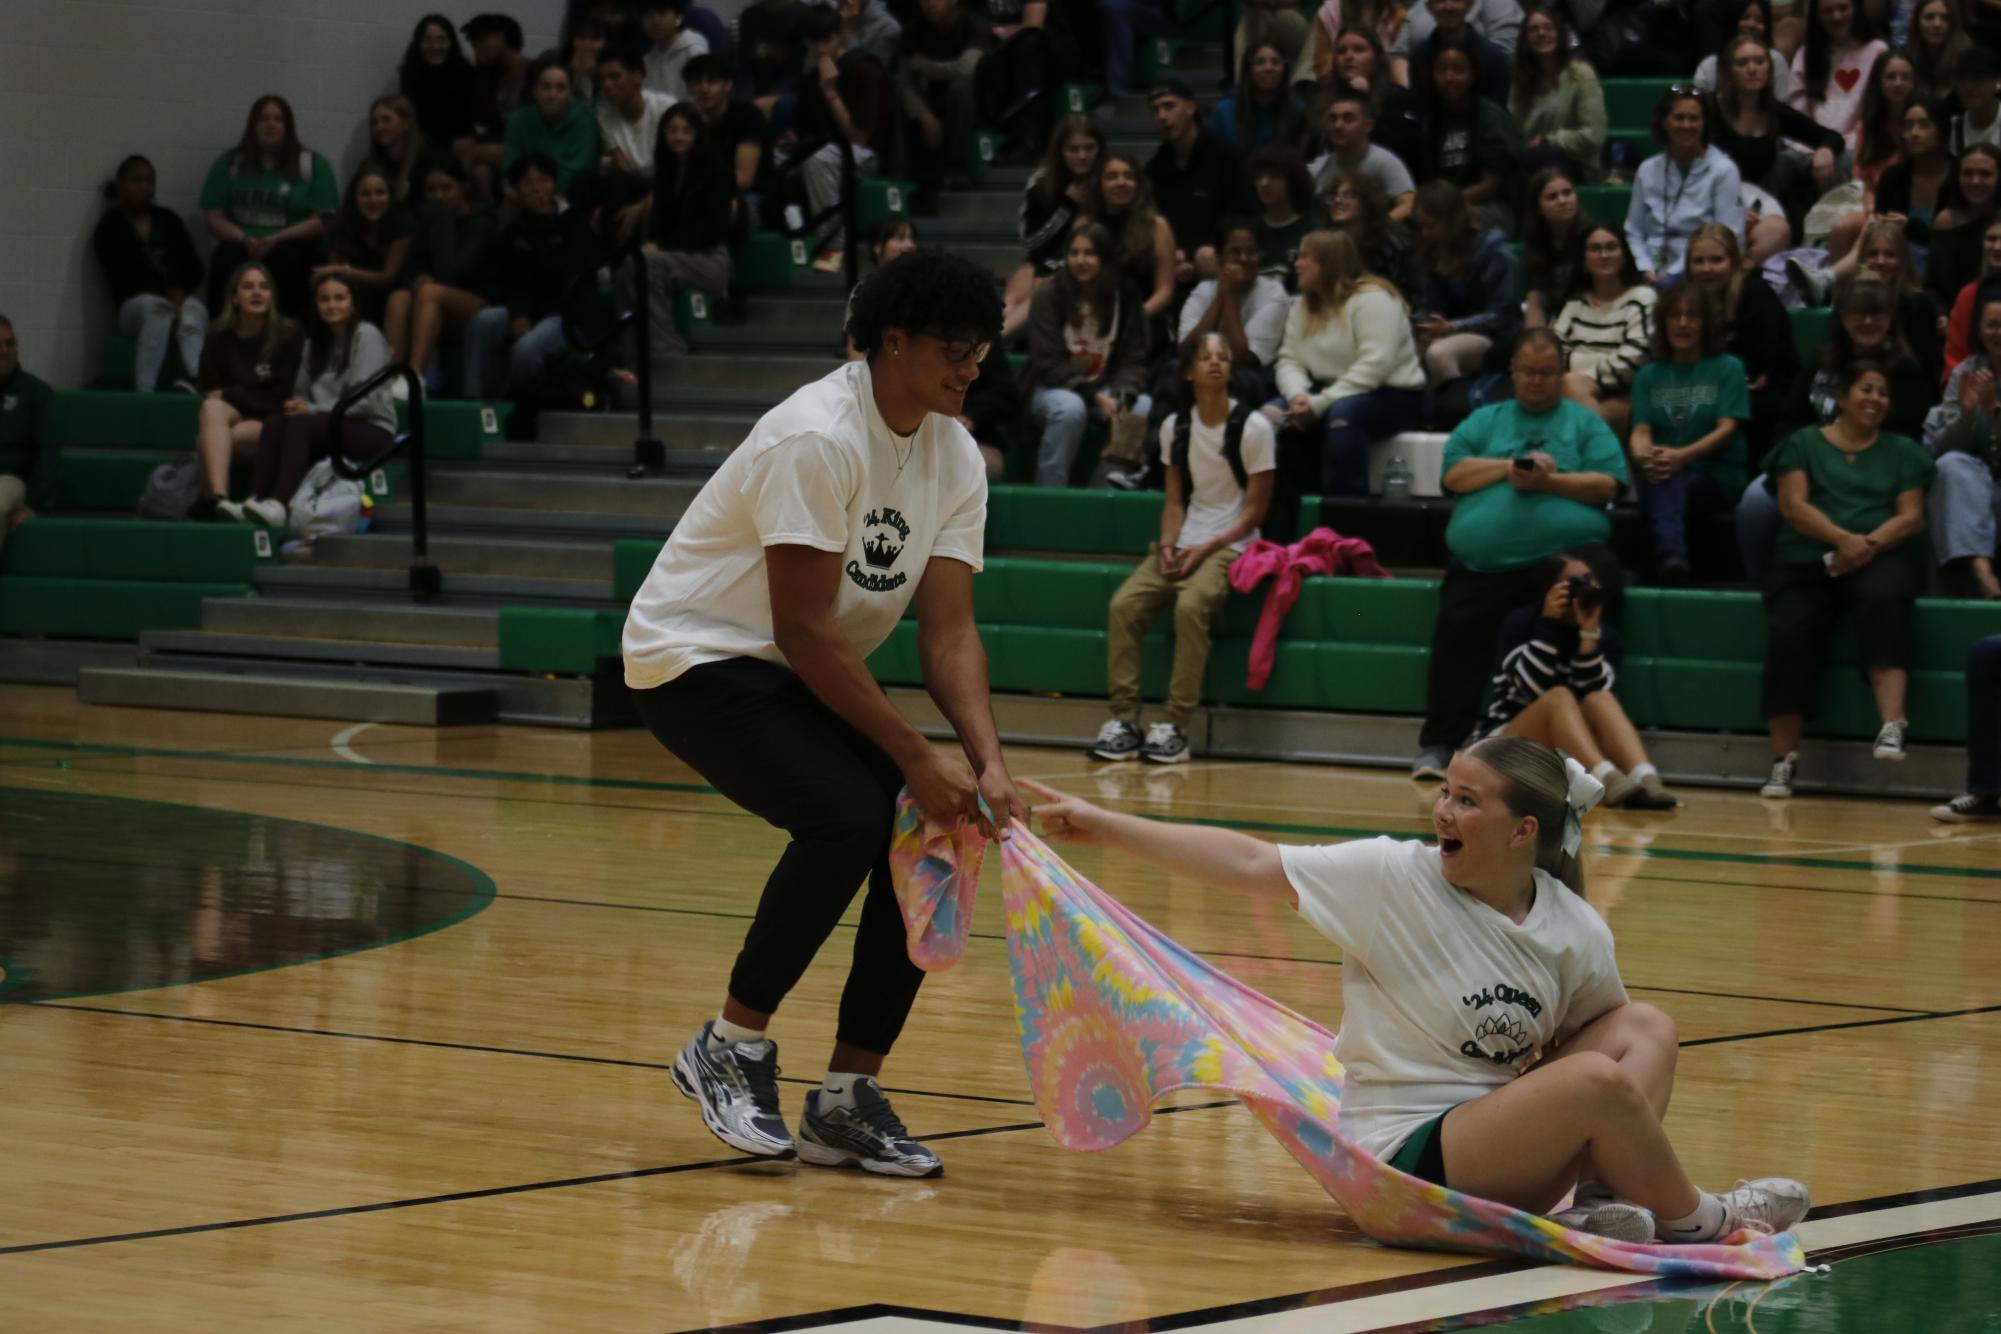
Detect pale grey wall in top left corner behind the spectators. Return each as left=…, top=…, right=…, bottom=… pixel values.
left=0, top=0, right=564, bottom=388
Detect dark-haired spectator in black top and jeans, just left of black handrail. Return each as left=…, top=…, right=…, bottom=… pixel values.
left=466, top=154, right=592, bottom=440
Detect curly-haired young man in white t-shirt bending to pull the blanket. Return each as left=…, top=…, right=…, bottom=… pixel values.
left=624, top=248, right=1027, bottom=1176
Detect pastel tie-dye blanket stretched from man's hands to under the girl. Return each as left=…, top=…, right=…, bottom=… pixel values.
left=890, top=796, right=1805, bottom=1278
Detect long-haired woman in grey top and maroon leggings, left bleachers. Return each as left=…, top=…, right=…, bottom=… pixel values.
left=216, top=274, right=396, bottom=528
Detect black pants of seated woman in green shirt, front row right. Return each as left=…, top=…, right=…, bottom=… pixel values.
left=1763, top=550, right=1923, bottom=718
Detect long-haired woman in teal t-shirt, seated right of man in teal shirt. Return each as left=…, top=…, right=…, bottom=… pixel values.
left=1629, top=282, right=1751, bottom=586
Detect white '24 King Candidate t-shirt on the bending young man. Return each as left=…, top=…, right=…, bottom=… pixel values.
left=622, top=362, right=986, bottom=690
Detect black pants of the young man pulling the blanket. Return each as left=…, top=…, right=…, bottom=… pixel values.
left=632, top=658, right=924, bottom=1054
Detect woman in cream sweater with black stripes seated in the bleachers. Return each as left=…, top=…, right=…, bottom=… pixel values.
left=1551, top=222, right=1659, bottom=436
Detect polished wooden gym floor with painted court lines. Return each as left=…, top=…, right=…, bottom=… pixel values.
left=0, top=688, right=2001, bottom=1332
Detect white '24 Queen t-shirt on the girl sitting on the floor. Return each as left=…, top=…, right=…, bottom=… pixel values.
left=1279, top=838, right=1627, bottom=1158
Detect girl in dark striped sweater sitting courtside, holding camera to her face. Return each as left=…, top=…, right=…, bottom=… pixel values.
left=1467, top=552, right=1679, bottom=810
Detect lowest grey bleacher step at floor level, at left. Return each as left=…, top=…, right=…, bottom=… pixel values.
left=76, top=668, right=498, bottom=726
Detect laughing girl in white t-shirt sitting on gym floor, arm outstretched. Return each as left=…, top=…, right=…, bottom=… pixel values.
left=1023, top=736, right=1809, bottom=1242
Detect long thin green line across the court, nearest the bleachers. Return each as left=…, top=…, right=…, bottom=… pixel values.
left=0, top=736, right=2001, bottom=880
